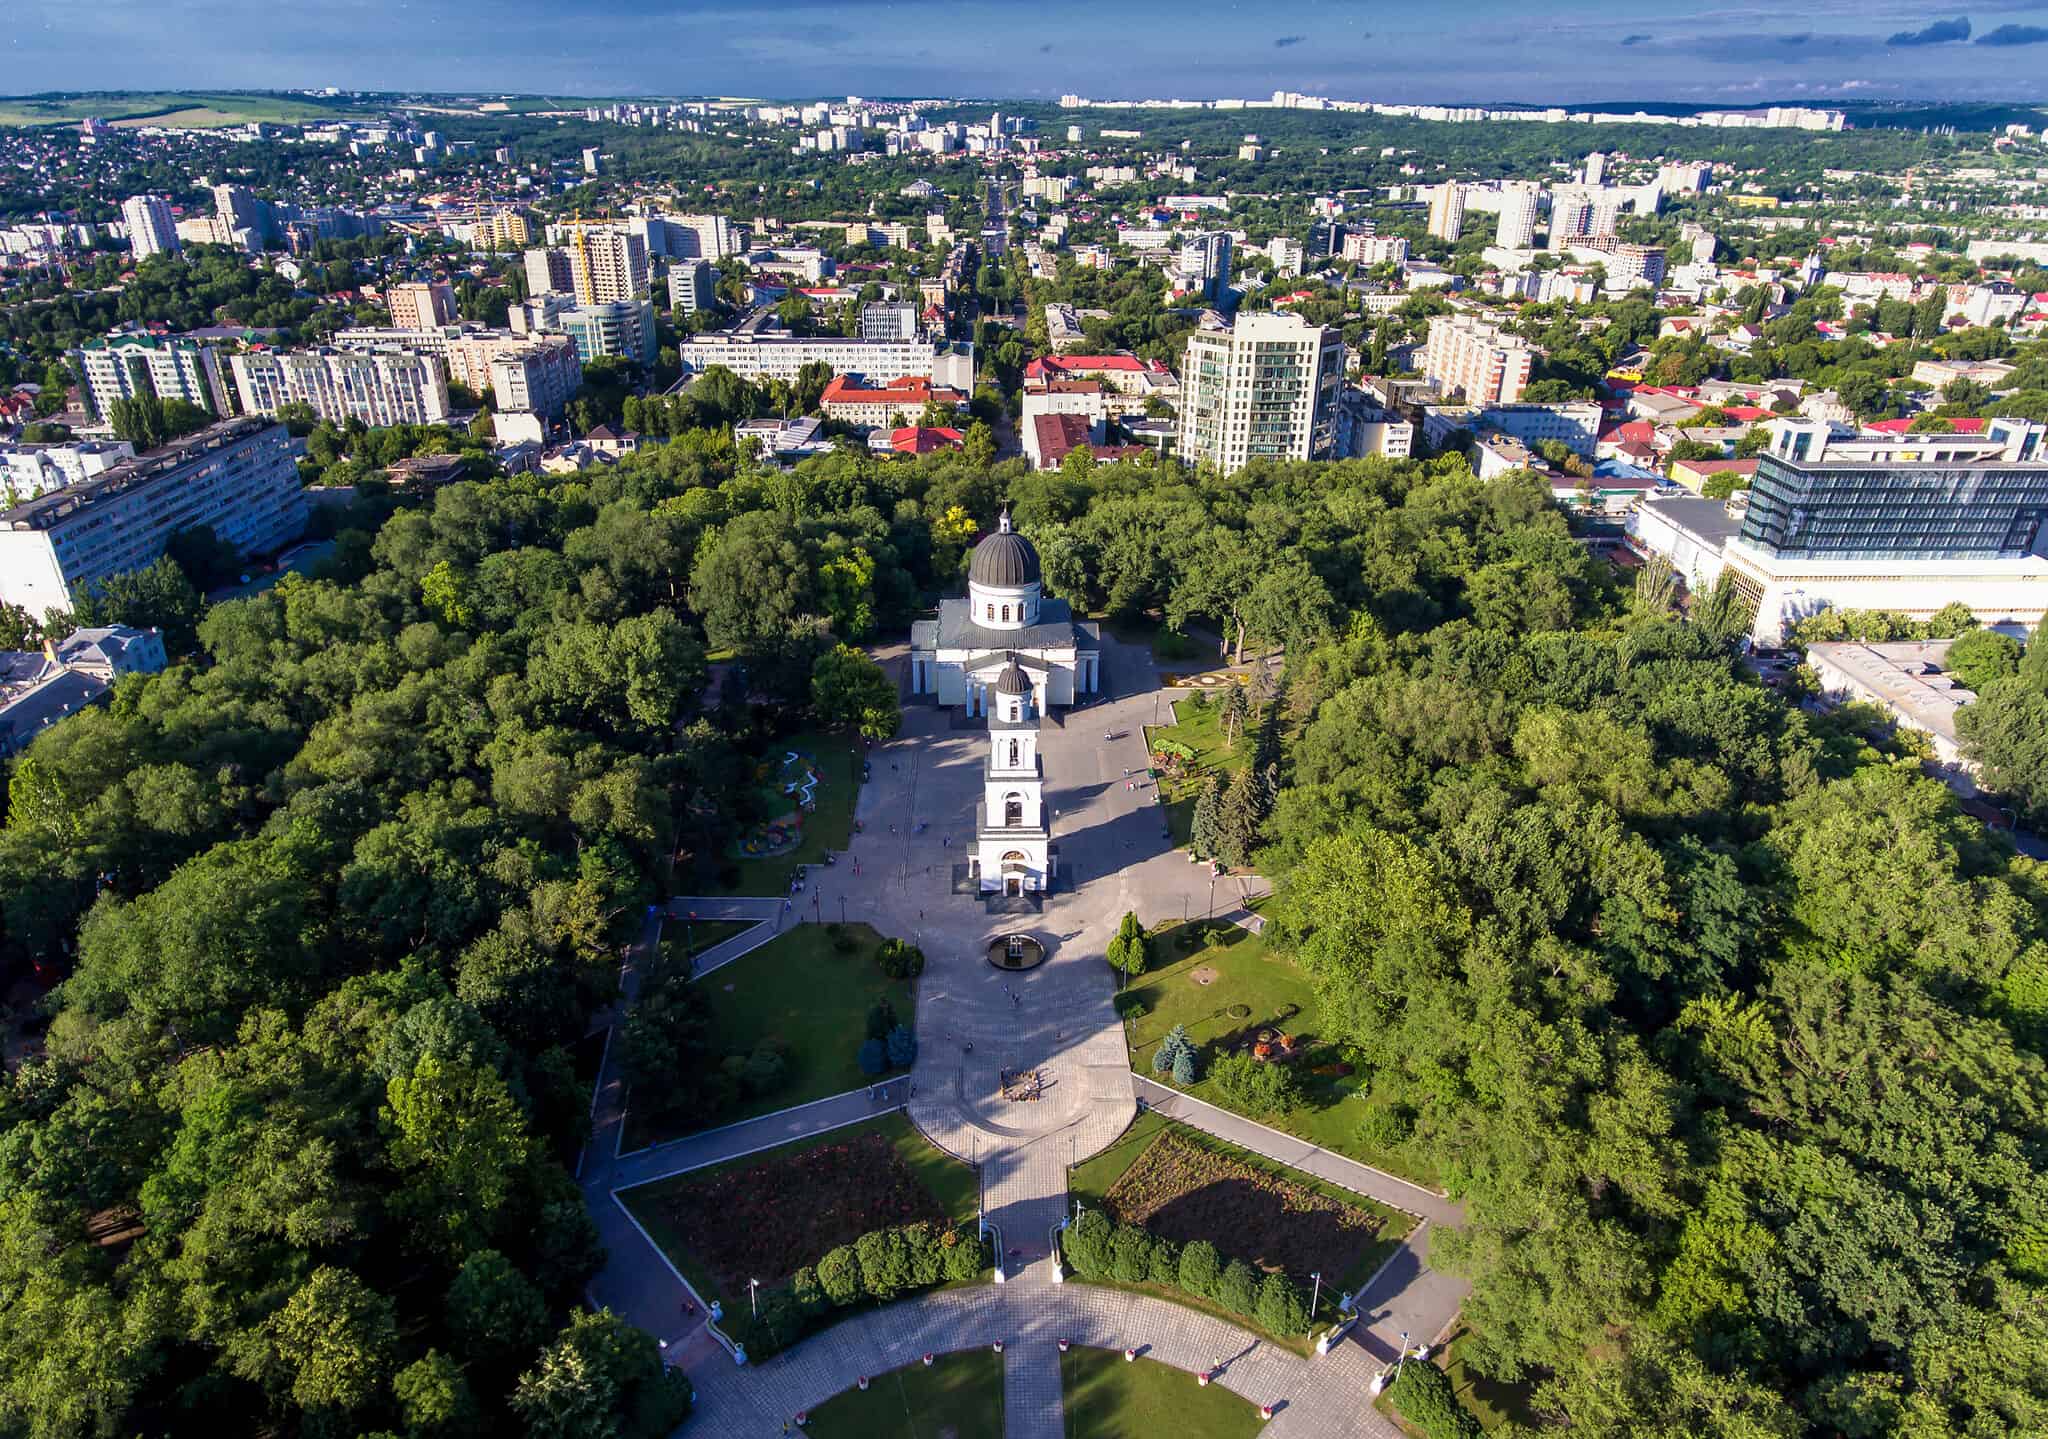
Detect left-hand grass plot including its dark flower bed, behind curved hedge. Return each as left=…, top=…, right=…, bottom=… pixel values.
left=618, top=1114, right=981, bottom=1337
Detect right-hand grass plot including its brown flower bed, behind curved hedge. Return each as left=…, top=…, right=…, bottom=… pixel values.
left=1067, top=1109, right=1415, bottom=1322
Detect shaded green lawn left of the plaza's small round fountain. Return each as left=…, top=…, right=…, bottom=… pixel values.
left=625, top=923, right=915, bottom=1150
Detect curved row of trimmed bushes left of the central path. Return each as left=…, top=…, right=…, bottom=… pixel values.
left=745, top=1224, right=989, bottom=1359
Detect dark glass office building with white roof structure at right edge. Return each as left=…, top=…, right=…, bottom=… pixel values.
left=1741, top=422, right=2048, bottom=561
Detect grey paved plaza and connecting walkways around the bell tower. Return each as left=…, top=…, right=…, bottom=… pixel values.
left=580, top=635, right=1464, bottom=1439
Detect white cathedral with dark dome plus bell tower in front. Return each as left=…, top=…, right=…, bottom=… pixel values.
left=909, top=519, right=1102, bottom=895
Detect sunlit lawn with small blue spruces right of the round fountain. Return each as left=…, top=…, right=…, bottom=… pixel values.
left=1118, top=921, right=1436, bottom=1185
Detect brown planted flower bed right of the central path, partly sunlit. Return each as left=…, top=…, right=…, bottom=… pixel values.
left=1104, top=1130, right=1382, bottom=1275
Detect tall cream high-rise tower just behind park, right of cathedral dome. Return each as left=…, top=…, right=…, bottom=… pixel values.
left=1180, top=313, right=1343, bottom=473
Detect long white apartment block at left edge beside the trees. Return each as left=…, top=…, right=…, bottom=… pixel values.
left=0, top=420, right=305, bottom=614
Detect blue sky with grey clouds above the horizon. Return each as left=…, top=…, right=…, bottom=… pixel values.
left=12, top=0, right=2048, bottom=104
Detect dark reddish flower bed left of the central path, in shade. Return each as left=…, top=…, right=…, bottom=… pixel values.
left=662, top=1134, right=946, bottom=1296
